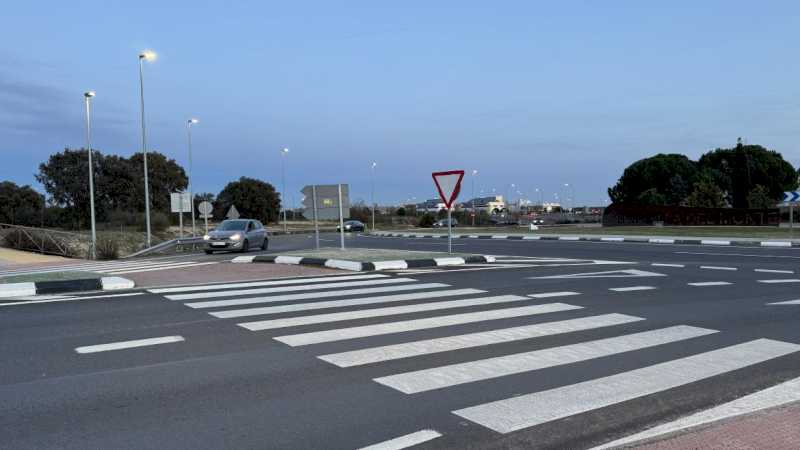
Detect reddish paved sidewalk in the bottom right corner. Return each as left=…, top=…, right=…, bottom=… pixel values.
left=635, top=404, right=800, bottom=450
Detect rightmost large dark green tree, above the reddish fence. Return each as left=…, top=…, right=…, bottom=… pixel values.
left=698, top=141, right=798, bottom=208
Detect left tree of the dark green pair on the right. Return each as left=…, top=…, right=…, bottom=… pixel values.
left=608, top=154, right=698, bottom=205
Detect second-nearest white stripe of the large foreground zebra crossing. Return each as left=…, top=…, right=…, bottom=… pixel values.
left=374, top=325, right=717, bottom=394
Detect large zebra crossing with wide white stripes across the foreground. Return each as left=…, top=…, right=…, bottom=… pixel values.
left=149, top=273, right=800, bottom=444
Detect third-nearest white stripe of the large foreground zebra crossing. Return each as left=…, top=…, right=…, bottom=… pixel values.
left=318, top=314, right=644, bottom=367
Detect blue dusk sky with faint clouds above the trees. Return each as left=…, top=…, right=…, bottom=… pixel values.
left=0, top=0, right=800, bottom=205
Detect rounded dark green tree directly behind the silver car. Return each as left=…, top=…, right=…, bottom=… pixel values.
left=214, top=177, right=281, bottom=223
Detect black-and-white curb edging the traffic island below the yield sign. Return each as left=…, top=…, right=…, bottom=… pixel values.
left=231, top=255, right=495, bottom=272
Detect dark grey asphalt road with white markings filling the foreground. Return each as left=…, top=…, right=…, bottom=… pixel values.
left=0, top=235, right=800, bottom=449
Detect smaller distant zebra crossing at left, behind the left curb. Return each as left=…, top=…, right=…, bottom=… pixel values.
left=0, top=258, right=218, bottom=277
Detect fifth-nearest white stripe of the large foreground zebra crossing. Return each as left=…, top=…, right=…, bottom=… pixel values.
left=238, top=295, right=529, bottom=331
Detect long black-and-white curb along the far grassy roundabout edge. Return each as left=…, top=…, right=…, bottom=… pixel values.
left=370, top=232, right=800, bottom=248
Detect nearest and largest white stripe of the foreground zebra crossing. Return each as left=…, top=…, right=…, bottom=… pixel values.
left=453, top=339, right=800, bottom=433
